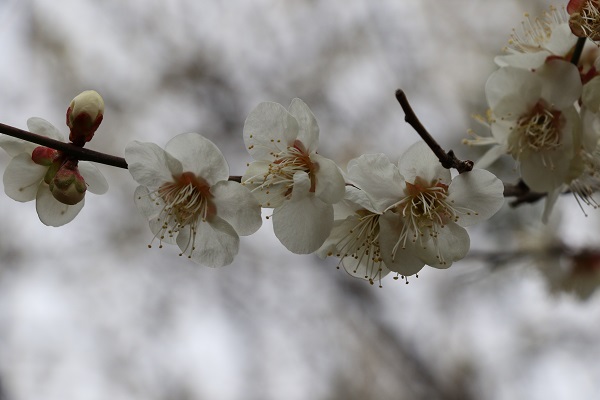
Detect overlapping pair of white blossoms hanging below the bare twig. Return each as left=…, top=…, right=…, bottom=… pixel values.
left=318, top=142, right=504, bottom=283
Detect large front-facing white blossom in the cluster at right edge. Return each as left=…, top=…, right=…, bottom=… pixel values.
left=478, top=60, right=582, bottom=192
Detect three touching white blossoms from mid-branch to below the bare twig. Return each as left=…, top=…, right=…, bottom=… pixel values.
left=242, top=99, right=504, bottom=283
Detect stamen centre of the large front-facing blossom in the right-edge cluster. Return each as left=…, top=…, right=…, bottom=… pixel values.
left=508, top=100, right=563, bottom=159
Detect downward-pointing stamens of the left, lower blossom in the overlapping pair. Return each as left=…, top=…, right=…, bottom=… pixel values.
left=328, top=210, right=383, bottom=285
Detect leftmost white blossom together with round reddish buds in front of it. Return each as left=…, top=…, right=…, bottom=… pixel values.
left=0, top=117, right=108, bottom=226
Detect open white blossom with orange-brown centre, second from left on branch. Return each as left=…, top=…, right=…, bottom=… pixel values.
left=125, top=133, right=262, bottom=267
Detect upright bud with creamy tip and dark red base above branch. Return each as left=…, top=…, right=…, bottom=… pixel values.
left=67, top=90, right=104, bottom=147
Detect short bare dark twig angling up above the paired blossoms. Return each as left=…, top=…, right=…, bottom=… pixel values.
left=396, top=89, right=473, bottom=174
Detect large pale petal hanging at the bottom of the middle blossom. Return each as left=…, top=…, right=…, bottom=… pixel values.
left=273, top=173, right=333, bottom=254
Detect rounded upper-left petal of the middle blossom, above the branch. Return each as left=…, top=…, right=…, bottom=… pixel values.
left=244, top=102, right=298, bottom=160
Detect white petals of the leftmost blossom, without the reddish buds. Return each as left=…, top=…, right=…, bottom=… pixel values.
left=0, top=117, right=108, bottom=226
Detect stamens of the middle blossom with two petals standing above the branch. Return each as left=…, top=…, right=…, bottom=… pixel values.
left=253, top=140, right=318, bottom=203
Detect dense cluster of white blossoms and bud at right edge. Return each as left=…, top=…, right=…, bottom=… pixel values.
left=465, top=0, right=600, bottom=219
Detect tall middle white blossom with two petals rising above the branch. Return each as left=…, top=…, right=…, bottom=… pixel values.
left=242, top=99, right=345, bottom=254
